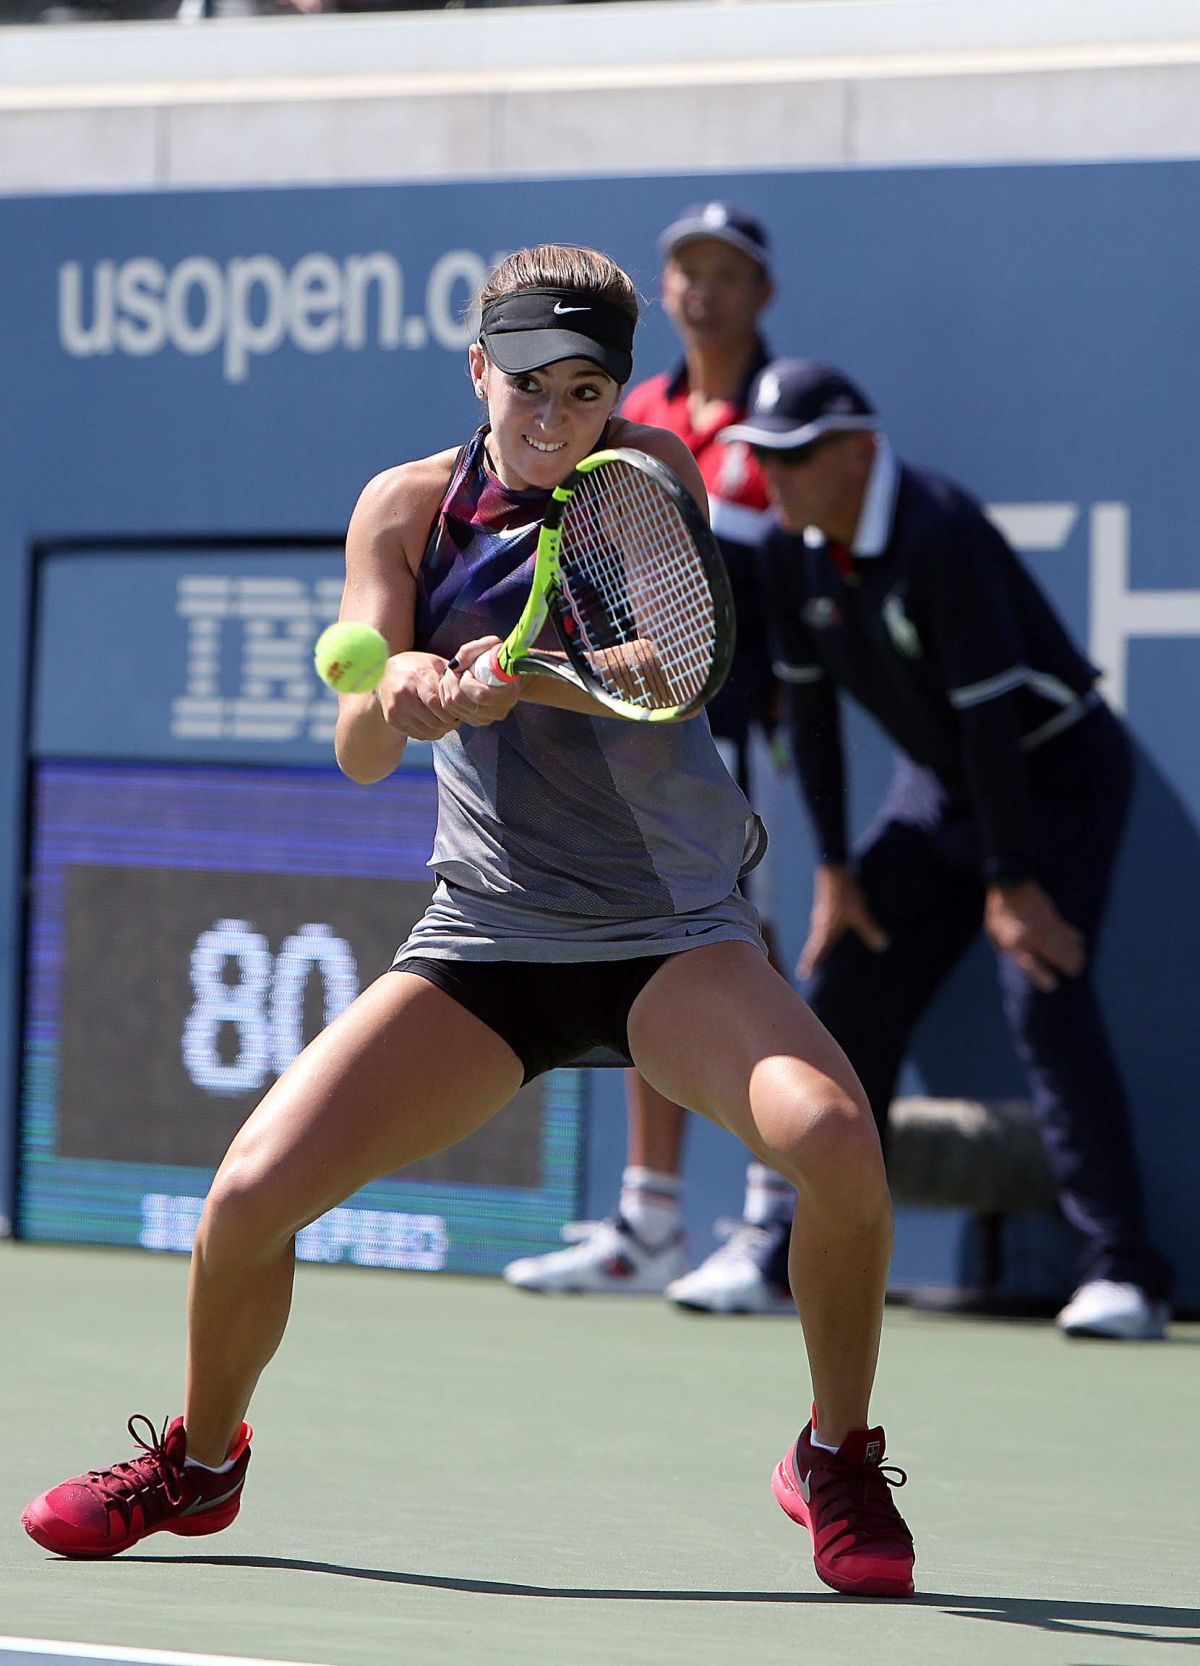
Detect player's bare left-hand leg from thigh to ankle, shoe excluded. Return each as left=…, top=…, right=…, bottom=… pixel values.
left=183, top=971, right=522, bottom=1464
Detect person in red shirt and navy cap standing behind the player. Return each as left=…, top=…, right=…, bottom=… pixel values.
left=505, top=202, right=795, bottom=1313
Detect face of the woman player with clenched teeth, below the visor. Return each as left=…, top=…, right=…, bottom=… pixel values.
left=472, top=348, right=620, bottom=491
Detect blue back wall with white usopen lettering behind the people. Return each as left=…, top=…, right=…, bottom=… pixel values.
left=0, top=163, right=1200, bottom=1304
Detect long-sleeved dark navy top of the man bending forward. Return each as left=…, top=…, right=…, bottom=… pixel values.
left=763, top=441, right=1100, bottom=880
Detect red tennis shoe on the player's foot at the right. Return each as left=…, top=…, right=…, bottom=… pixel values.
left=772, top=1423, right=915, bottom=1596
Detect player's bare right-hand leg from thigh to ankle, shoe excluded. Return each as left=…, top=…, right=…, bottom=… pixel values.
left=630, top=943, right=892, bottom=1444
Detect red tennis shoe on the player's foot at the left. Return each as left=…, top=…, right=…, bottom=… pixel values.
left=22, top=1416, right=253, bottom=1556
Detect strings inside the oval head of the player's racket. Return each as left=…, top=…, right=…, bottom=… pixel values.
left=560, top=463, right=717, bottom=710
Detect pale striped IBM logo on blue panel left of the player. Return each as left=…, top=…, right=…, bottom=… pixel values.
left=172, top=576, right=342, bottom=745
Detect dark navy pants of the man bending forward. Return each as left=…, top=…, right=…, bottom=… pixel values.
left=808, top=708, right=1170, bottom=1296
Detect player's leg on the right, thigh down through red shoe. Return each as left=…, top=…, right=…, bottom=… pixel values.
left=628, top=943, right=913, bottom=1596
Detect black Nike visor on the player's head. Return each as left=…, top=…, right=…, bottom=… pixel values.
left=480, top=290, right=633, bottom=387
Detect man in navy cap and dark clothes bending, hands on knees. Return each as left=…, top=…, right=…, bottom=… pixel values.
left=723, top=360, right=1168, bottom=1341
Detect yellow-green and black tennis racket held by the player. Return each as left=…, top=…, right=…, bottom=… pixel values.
left=472, top=450, right=733, bottom=723
